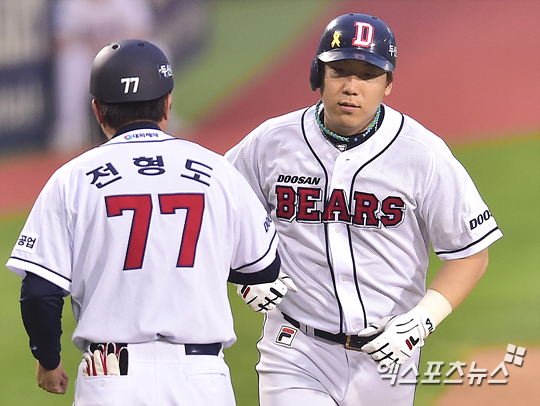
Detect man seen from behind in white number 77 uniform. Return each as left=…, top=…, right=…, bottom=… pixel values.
left=7, top=40, right=296, bottom=406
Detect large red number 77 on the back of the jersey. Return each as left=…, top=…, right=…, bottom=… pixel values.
left=105, top=193, right=204, bottom=270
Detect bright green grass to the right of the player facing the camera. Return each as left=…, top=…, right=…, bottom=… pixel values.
left=415, top=136, right=540, bottom=406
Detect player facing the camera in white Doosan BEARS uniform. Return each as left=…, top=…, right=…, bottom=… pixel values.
left=226, top=14, right=502, bottom=406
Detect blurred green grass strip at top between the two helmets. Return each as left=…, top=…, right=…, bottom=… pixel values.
left=173, top=0, right=331, bottom=125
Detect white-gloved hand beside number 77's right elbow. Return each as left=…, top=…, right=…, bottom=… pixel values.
left=236, top=272, right=298, bottom=313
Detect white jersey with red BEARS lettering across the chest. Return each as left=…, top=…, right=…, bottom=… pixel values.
left=226, top=106, right=502, bottom=334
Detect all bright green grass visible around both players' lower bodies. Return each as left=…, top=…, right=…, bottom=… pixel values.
left=0, top=135, right=540, bottom=406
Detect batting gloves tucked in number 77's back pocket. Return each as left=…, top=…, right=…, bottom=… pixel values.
left=83, top=343, right=128, bottom=376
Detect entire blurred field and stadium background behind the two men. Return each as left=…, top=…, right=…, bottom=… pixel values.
left=0, top=0, right=540, bottom=406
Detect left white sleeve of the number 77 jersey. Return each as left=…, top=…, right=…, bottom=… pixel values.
left=6, top=163, right=72, bottom=292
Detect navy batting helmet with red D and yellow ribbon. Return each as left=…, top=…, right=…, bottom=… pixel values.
left=309, top=13, right=397, bottom=91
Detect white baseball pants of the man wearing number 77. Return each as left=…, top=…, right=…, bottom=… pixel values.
left=73, top=341, right=236, bottom=406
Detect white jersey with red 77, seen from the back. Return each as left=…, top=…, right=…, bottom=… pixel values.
left=7, top=129, right=277, bottom=351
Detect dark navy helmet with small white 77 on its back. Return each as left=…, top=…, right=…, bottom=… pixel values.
left=90, top=39, right=174, bottom=103
